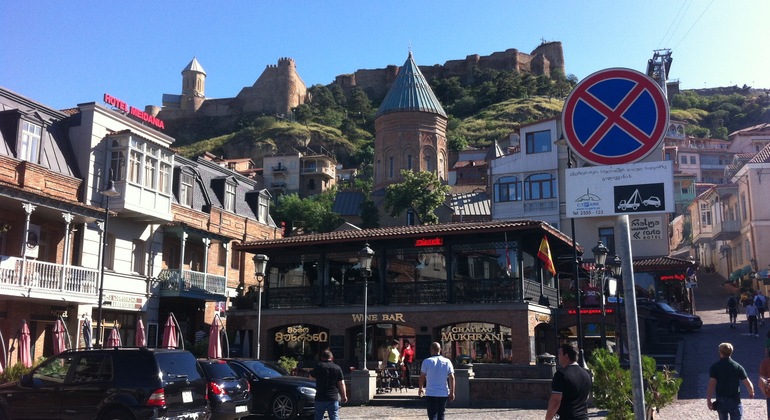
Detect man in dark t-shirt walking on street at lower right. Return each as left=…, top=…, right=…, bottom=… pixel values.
left=706, top=343, right=754, bottom=420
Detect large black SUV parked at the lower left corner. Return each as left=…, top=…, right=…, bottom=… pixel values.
left=0, top=348, right=211, bottom=420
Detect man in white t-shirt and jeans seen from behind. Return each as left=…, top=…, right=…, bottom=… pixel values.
left=417, top=342, right=455, bottom=420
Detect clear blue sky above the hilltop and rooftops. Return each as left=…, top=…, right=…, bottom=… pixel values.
left=0, top=0, right=770, bottom=109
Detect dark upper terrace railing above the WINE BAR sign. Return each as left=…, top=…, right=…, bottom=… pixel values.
left=260, top=278, right=558, bottom=309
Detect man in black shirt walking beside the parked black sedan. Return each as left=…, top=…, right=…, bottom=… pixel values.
left=311, top=350, right=348, bottom=420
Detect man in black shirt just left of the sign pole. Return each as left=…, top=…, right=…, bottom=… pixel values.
left=545, top=344, right=592, bottom=420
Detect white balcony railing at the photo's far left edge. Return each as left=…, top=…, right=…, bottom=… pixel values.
left=0, top=257, right=99, bottom=296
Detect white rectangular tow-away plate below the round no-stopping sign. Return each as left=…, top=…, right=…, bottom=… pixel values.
left=565, top=161, right=674, bottom=217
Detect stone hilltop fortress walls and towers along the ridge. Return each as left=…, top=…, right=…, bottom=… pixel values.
left=145, top=41, right=564, bottom=121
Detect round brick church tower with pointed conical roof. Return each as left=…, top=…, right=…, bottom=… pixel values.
left=374, top=51, right=448, bottom=190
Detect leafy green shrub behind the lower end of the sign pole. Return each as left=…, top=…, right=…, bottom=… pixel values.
left=591, top=349, right=682, bottom=420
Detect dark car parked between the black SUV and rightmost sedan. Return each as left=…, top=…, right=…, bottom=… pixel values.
left=198, top=359, right=251, bottom=420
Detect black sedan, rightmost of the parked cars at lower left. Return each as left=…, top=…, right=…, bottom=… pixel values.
left=225, top=359, right=315, bottom=420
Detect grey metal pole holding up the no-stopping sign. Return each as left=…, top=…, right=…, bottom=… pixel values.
left=615, top=214, right=647, bottom=420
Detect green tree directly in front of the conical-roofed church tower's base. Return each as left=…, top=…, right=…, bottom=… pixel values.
left=384, top=170, right=449, bottom=225
